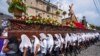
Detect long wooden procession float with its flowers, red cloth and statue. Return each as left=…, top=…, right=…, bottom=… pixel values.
left=8, top=1, right=96, bottom=38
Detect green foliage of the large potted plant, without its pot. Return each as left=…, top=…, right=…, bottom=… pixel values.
left=8, top=0, right=27, bottom=13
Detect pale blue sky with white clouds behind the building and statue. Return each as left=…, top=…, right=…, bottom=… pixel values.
left=0, top=0, right=100, bottom=26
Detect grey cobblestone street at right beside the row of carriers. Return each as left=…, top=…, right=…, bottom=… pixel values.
left=78, top=42, right=100, bottom=56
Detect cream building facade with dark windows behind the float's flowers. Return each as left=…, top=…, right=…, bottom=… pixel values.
left=7, top=0, right=62, bottom=23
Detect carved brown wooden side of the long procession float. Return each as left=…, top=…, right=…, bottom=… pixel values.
left=8, top=16, right=96, bottom=38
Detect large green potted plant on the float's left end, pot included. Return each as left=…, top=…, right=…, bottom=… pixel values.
left=8, top=0, right=26, bottom=17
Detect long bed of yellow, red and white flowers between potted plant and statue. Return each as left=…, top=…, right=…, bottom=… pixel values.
left=25, top=16, right=61, bottom=26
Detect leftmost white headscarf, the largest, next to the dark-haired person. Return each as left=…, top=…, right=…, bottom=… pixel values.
left=19, top=34, right=32, bottom=52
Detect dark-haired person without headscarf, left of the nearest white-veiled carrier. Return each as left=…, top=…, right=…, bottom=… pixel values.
left=3, top=36, right=19, bottom=56
